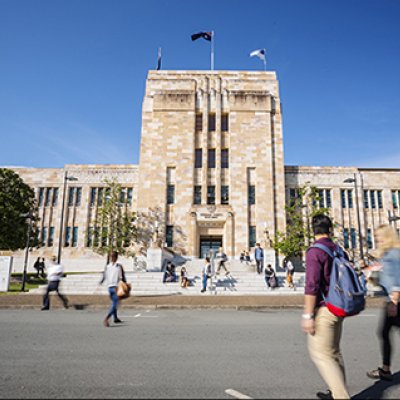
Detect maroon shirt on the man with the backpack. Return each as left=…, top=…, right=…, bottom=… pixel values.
left=304, top=238, right=336, bottom=307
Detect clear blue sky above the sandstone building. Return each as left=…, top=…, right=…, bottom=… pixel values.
left=0, top=0, right=400, bottom=168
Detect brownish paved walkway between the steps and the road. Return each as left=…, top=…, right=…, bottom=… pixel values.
left=0, top=293, right=383, bottom=310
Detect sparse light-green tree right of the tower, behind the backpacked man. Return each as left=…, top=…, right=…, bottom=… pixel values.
left=272, top=186, right=329, bottom=258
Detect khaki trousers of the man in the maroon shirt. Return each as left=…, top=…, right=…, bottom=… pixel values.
left=308, top=307, right=350, bottom=399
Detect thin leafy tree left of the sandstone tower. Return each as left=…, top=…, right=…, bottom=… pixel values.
left=89, top=180, right=137, bottom=257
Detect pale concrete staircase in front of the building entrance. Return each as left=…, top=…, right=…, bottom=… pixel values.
left=29, top=260, right=304, bottom=296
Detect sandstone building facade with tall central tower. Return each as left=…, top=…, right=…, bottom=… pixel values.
left=8, top=71, right=400, bottom=271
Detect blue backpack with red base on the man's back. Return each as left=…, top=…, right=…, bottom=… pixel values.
left=312, top=243, right=367, bottom=317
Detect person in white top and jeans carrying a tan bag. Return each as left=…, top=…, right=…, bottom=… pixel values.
left=100, top=251, right=126, bottom=327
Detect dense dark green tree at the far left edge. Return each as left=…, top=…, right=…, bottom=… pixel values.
left=0, top=168, right=37, bottom=251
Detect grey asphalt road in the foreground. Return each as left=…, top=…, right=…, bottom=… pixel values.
left=0, top=309, right=400, bottom=399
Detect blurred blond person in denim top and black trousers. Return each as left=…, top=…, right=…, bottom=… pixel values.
left=367, top=225, right=400, bottom=381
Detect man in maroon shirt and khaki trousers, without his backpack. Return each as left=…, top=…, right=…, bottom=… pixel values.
left=301, top=215, right=350, bottom=399
